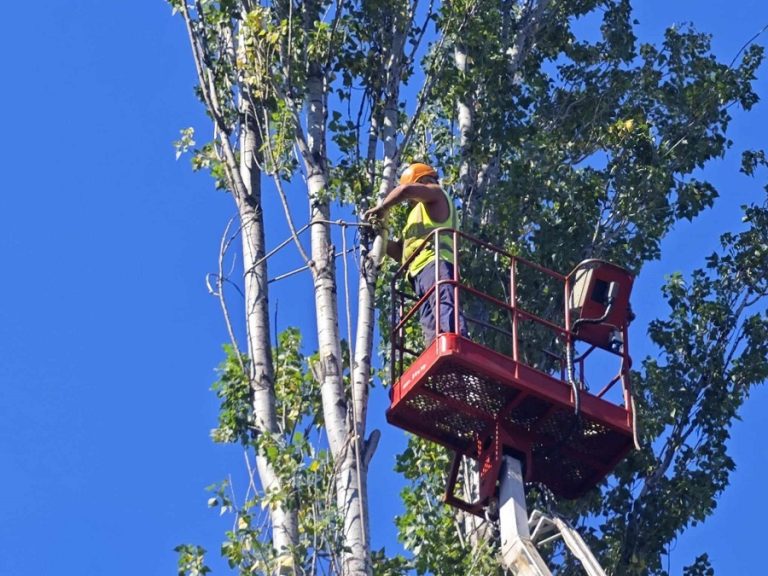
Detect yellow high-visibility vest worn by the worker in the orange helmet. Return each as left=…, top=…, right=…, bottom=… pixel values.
left=402, top=190, right=459, bottom=277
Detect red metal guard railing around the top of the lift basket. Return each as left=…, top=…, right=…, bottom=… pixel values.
left=390, top=228, right=631, bottom=410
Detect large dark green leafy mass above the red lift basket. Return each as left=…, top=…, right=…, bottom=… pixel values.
left=422, top=2, right=762, bottom=270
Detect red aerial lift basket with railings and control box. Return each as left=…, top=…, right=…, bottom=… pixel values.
left=387, top=229, right=634, bottom=514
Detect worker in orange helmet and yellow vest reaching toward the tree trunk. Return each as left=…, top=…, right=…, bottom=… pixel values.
left=363, top=162, right=467, bottom=344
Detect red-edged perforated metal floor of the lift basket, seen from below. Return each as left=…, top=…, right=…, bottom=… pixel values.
left=387, top=334, right=633, bottom=498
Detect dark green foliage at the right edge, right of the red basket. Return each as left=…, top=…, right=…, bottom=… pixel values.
left=600, top=197, right=768, bottom=574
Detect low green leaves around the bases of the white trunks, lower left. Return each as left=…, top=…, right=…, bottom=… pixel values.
left=204, top=328, right=341, bottom=576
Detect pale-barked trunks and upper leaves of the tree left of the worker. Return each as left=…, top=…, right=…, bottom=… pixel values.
left=171, top=1, right=428, bottom=574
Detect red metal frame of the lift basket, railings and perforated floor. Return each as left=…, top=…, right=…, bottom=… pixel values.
left=387, top=229, right=634, bottom=514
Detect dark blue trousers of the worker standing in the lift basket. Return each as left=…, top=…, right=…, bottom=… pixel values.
left=413, top=260, right=467, bottom=345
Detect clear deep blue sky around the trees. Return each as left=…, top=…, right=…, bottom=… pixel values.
left=0, top=0, right=768, bottom=576
